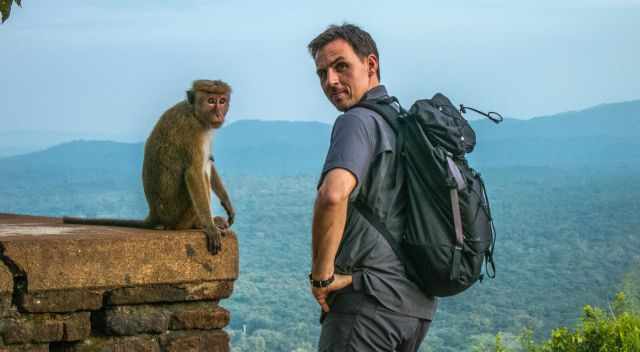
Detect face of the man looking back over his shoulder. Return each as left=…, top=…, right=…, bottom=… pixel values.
left=315, top=39, right=379, bottom=111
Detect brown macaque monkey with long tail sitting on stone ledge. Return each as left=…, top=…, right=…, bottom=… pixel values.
left=63, top=80, right=235, bottom=254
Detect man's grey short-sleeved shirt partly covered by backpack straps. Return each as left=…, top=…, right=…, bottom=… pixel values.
left=319, top=85, right=436, bottom=320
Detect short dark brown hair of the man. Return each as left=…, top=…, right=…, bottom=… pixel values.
left=307, top=23, right=380, bottom=79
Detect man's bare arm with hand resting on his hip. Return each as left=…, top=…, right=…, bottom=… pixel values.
left=311, top=168, right=357, bottom=312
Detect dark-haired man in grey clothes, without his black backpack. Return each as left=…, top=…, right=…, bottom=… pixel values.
left=309, top=24, right=435, bottom=352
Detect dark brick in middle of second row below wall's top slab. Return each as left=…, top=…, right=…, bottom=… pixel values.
left=93, top=305, right=169, bottom=336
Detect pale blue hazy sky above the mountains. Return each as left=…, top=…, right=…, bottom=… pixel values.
left=0, top=0, right=640, bottom=141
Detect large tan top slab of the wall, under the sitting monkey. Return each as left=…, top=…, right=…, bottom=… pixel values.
left=0, top=214, right=239, bottom=294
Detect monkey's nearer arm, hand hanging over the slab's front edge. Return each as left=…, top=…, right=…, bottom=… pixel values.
left=185, top=164, right=221, bottom=254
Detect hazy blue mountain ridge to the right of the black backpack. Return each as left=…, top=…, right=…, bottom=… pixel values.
left=471, top=100, right=640, bottom=167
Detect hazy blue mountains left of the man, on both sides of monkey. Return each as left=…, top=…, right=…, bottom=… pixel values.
left=0, top=121, right=331, bottom=188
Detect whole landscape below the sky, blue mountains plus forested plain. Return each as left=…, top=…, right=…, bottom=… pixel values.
left=0, top=101, right=640, bottom=352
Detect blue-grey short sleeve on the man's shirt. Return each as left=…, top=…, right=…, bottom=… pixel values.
left=318, top=114, right=373, bottom=193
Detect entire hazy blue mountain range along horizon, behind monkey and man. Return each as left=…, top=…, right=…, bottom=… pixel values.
left=0, top=100, right=640, bottom=178
